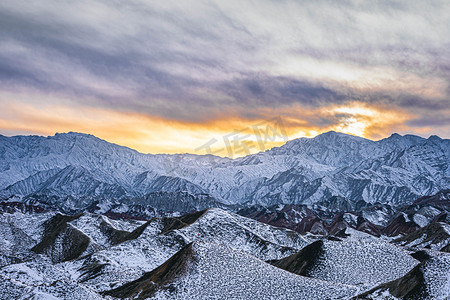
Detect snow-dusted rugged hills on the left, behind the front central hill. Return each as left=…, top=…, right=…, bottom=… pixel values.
left=0, top=209, right=309, bottom=299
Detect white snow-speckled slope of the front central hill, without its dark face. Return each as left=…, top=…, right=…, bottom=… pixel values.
left=153, top=242, right=358, bottom=299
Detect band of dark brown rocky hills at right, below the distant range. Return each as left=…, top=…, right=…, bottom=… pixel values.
left=238, top=190, right=450, bottom=240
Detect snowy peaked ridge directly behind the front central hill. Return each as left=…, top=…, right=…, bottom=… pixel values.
left=63, top=209, right=308, bottom=290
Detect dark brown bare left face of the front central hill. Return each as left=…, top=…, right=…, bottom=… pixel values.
left=103, top=243, right=194, bottom=299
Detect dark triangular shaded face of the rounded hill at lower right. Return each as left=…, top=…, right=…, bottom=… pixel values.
left=268, top=240, right=323, bottom=276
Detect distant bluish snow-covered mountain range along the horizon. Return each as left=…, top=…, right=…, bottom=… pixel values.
left=0, top=132, right=450, bottom=213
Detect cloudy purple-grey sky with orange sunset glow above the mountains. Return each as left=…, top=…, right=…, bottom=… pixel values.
left=0, top=0, right=450, bottom=157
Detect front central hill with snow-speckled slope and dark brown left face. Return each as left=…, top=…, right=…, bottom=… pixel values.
left=105, top=242, right=357, bottom=299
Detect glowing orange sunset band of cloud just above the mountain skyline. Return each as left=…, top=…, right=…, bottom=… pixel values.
left=0, top=96, right=422, bottom=157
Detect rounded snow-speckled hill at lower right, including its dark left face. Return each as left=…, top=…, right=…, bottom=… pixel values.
left=270, top=240, right=419, bottom=288
